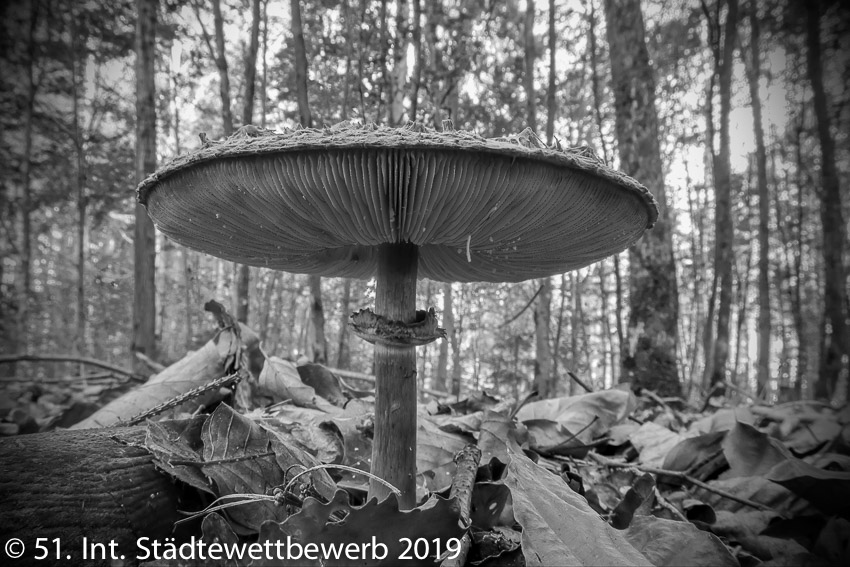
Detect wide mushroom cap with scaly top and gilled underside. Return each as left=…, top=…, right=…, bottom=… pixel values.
left=138, top=125, right=658, bottom=282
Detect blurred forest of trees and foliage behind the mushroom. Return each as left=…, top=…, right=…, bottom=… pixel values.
left=0, top=0, right=850, bottom=408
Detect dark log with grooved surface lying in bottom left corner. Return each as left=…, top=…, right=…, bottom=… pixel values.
left=0, top=427, right=186, bottom=566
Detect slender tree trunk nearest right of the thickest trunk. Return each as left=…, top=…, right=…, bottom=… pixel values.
left=711, top=0, right=738, bottom=385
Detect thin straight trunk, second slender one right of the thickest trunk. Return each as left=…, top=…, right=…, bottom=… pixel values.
left=749, top=0, right=770, bottom=395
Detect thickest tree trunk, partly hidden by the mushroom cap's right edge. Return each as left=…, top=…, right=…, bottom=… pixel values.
left=605, top=0, right=681, bottom=396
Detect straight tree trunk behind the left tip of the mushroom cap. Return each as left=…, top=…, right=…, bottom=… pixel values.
left=132, top=0, right=157, bottom=364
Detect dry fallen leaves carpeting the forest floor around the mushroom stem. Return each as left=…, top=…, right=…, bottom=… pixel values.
left=141, top=357, right=850, bottom=567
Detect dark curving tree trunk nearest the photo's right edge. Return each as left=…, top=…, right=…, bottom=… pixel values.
left=806, top=0, right=850, bottom=399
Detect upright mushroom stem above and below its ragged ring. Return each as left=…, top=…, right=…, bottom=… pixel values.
left=369, top=243, right=419, bottom=510
